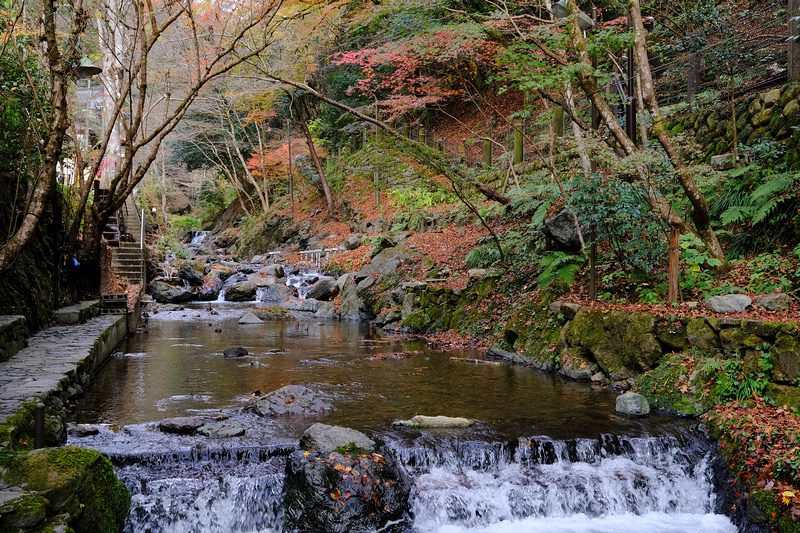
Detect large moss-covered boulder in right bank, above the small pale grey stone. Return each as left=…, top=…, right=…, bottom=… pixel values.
left=566, top=308, right=662, bottom=379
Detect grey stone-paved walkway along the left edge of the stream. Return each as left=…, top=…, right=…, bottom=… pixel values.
left=0, top=315, right=126, bottom=423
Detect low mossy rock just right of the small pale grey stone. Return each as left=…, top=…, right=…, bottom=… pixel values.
left=636, top=354, right=714, bottom=416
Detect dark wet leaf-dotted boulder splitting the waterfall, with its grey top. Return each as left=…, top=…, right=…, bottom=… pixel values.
left=283, top=424, right=410, bottom=533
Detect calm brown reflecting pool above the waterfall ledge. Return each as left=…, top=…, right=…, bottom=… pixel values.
left=72, top=305, right=692, bottom=438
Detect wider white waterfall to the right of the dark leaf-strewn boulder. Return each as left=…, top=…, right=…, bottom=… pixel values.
left=388, top=435, right=736, bottom=533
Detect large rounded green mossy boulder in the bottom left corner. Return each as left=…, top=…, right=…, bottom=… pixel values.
left=4, top=446, right=131, bottom=533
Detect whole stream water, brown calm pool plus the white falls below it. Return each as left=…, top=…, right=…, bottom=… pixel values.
left=69, top=303, right=736, bottom=533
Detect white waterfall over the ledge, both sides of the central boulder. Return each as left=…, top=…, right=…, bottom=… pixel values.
left=92, top=432, right=737, bottom=533
